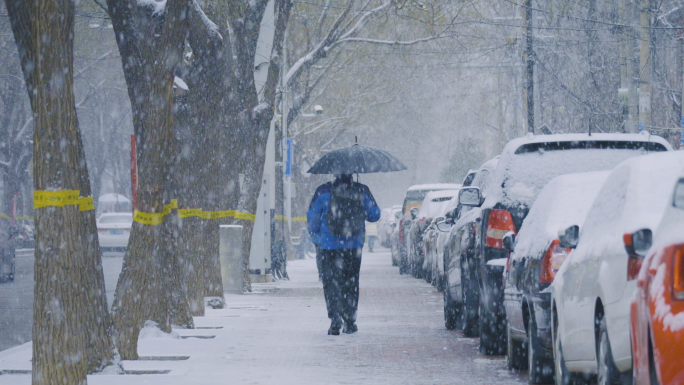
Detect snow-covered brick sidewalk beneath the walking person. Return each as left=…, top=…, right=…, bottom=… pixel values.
left=0, top=249, right=525, bottom=385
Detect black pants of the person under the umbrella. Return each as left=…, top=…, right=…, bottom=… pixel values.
left=321, top=249, right=361, bottom=323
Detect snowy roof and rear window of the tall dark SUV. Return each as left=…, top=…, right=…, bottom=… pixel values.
left=482, top=134, right=672, bottom=208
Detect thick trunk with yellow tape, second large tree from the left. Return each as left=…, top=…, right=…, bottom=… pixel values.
left=107, top=0, right=189, bottom=360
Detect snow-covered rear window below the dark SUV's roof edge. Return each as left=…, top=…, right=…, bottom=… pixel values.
left=487, top=142, right=665, bottom=208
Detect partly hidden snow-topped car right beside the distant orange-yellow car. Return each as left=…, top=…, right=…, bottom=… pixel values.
left=406, top=185, right=460, bottom=278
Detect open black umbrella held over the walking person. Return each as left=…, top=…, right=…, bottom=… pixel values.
left=307, top=140, right=406, bottom=174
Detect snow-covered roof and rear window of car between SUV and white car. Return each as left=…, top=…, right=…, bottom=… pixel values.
left=511, top=171, right=610, bottom=259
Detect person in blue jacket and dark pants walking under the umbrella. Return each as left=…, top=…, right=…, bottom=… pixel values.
left=307, top=174, right=380, bottom=335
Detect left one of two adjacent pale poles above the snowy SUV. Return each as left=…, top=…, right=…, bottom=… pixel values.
left=618, top=0, right=639, bottom=133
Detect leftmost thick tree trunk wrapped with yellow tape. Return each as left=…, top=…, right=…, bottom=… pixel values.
left=7, top=0, right=114, bottom=384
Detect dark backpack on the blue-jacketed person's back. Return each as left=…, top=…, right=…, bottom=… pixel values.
left=325, top=183, right=366, bottom=239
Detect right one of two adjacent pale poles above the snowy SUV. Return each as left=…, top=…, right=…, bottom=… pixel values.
left=639, top=0, right=653, bottom=131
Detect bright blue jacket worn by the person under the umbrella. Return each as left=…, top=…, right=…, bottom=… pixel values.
left=306, top=182, right=381, bottom=250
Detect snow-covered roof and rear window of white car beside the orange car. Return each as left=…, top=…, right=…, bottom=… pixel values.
left=573, top=151, right=684, bottom=264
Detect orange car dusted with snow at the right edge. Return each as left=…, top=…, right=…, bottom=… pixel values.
left=625, top=177, right=684, bottom=385
